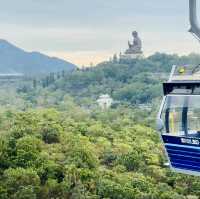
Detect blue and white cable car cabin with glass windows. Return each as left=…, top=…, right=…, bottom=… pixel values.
left=157, top=66, right=200, bottom=175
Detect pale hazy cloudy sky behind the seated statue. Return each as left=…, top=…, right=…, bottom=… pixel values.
left=0, top=0, right=200, bottom=65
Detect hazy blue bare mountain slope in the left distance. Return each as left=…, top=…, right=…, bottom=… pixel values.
left=0, top=39, right=76, bottom=75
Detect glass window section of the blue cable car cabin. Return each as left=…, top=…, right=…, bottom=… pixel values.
left=161, top=95, right=200, bottom=138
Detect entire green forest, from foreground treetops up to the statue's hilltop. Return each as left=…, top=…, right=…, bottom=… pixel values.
left=0, top=53, right=200, bottom=199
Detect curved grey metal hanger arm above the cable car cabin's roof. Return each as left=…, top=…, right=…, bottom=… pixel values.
left=189, top=0, right=200, bottom=41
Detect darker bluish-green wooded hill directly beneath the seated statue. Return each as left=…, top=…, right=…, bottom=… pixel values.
left=18, top=53, right=200, bottom=106
